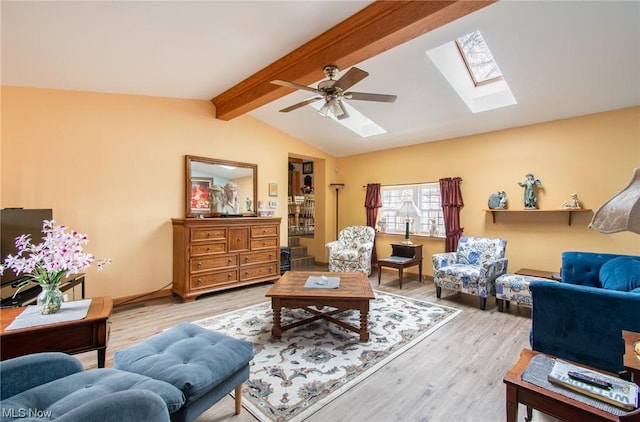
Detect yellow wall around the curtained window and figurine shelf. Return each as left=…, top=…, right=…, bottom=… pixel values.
left=338, top=107, right=640, bottom=275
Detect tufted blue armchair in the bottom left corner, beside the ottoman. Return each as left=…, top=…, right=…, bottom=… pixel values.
left=0, top=352, right=184, bottom=422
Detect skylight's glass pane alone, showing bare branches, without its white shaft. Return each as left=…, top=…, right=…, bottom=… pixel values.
left=456, top=31, right=502, bottom=85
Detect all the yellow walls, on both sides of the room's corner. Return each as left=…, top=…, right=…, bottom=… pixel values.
left=0, top=87, right=640, bottom=298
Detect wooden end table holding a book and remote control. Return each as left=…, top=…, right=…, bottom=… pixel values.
left=503, top=349, right=618, bottom=422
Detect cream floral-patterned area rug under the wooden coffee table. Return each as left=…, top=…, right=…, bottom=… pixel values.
left=194, top=291, right=461, bottom=422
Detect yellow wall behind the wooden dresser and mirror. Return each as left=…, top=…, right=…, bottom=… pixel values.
left=0, top=86, right=335, bottom=298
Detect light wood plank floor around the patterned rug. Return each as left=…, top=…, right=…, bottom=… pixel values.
left=77, top=268, right=556, bottom=422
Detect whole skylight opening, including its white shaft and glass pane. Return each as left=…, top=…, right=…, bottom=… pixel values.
left=427, top=31, right=517, bottom=113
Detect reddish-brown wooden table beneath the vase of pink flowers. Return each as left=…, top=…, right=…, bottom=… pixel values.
left=0, top=296, right=113, bottom=368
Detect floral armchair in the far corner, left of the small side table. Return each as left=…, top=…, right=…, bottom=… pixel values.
left=326, top=226, right=376, bottom=275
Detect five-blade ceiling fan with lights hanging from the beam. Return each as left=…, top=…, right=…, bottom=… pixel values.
left=271, top=65, right=397, bottom=120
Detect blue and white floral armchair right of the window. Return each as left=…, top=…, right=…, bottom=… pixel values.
left=433, top=236, right=508, bottom=310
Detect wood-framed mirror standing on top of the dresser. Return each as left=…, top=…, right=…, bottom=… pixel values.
left=185, top=155, right=258, bottom=217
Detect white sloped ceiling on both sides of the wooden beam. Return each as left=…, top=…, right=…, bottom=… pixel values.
left=0, top=0, right=640, bottom=157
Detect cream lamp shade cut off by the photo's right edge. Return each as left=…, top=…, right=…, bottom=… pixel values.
left=589, top=168, right=640, bottom=234
